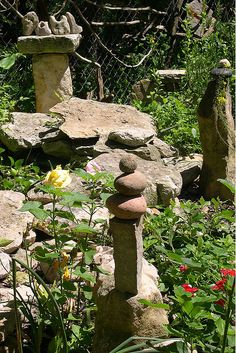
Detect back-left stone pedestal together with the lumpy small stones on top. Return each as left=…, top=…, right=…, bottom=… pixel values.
left=17, top=12, right=82, bottom=113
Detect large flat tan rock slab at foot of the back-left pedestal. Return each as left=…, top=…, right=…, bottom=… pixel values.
left=50, top=98, right=155, bottom=140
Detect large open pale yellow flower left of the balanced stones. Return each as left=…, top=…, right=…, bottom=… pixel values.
left=43, top=165, right=71, bottom=188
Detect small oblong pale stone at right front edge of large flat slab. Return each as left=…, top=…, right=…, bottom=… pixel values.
left=108, top=128, right=155, bottom=147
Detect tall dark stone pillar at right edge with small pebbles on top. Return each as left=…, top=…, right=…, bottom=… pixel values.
left=198, top=59, right=235, bottom=200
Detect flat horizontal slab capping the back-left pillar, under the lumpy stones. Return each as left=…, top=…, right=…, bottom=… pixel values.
left=17, top=34, right=82, bottom=54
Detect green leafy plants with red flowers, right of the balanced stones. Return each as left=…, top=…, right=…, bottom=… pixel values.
left=144, top=199, right=235, bottom=353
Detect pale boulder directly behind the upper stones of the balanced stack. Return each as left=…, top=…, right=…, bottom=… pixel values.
left=91, top=150, right=182, bottom=206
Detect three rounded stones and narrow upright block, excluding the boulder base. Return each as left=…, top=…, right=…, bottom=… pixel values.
left=106, top=155, right=147, bottom=295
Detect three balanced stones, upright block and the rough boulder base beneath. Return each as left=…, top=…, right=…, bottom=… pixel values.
left=93, top=155, right=168, bottom=353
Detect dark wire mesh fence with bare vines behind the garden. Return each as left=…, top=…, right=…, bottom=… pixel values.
left=0, top=0, right=234, bottom=107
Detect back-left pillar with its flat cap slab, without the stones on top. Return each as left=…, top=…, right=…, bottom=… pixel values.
left=18, top=34, right=81, bottom=113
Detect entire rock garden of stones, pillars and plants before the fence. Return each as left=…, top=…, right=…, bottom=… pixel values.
left=0, top=0, right=233, bottom=353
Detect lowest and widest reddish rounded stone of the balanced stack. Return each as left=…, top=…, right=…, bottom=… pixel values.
left=106, top=194, right=147, bottom=219
